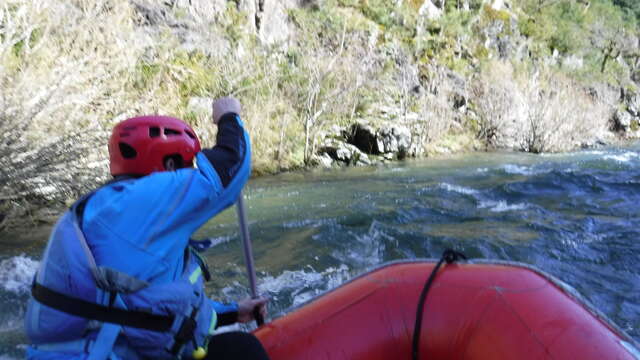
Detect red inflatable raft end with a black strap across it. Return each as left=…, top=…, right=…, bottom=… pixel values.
left=255, top=261, right=640, bottom=360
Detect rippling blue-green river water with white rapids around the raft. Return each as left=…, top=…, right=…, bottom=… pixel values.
left=0, top=144, right=640, bottom=360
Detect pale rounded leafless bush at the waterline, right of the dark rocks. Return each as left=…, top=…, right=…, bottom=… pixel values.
left=471, top=62, right=611, bottom=153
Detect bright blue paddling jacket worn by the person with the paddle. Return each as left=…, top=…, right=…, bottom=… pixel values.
left=25, top=114, right=251, bottom=359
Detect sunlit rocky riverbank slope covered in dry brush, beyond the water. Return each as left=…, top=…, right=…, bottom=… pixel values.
left=0, top=0, right=640, bottom=229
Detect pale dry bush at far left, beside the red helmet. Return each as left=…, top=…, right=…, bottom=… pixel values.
left=0, top=0, right=142, bottom=229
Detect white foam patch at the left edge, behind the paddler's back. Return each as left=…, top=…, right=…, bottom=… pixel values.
left=0, top=255, right=40, bottom=294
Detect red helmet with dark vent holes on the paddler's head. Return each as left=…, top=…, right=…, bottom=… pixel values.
left=109, top=115, right=200, bottom=176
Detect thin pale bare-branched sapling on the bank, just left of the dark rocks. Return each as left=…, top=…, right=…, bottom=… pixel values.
left=283, top=6, right=374, bottom=164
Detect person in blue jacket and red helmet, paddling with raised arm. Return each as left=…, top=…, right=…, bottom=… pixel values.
left=25, top=97, right=268, bottom=360
